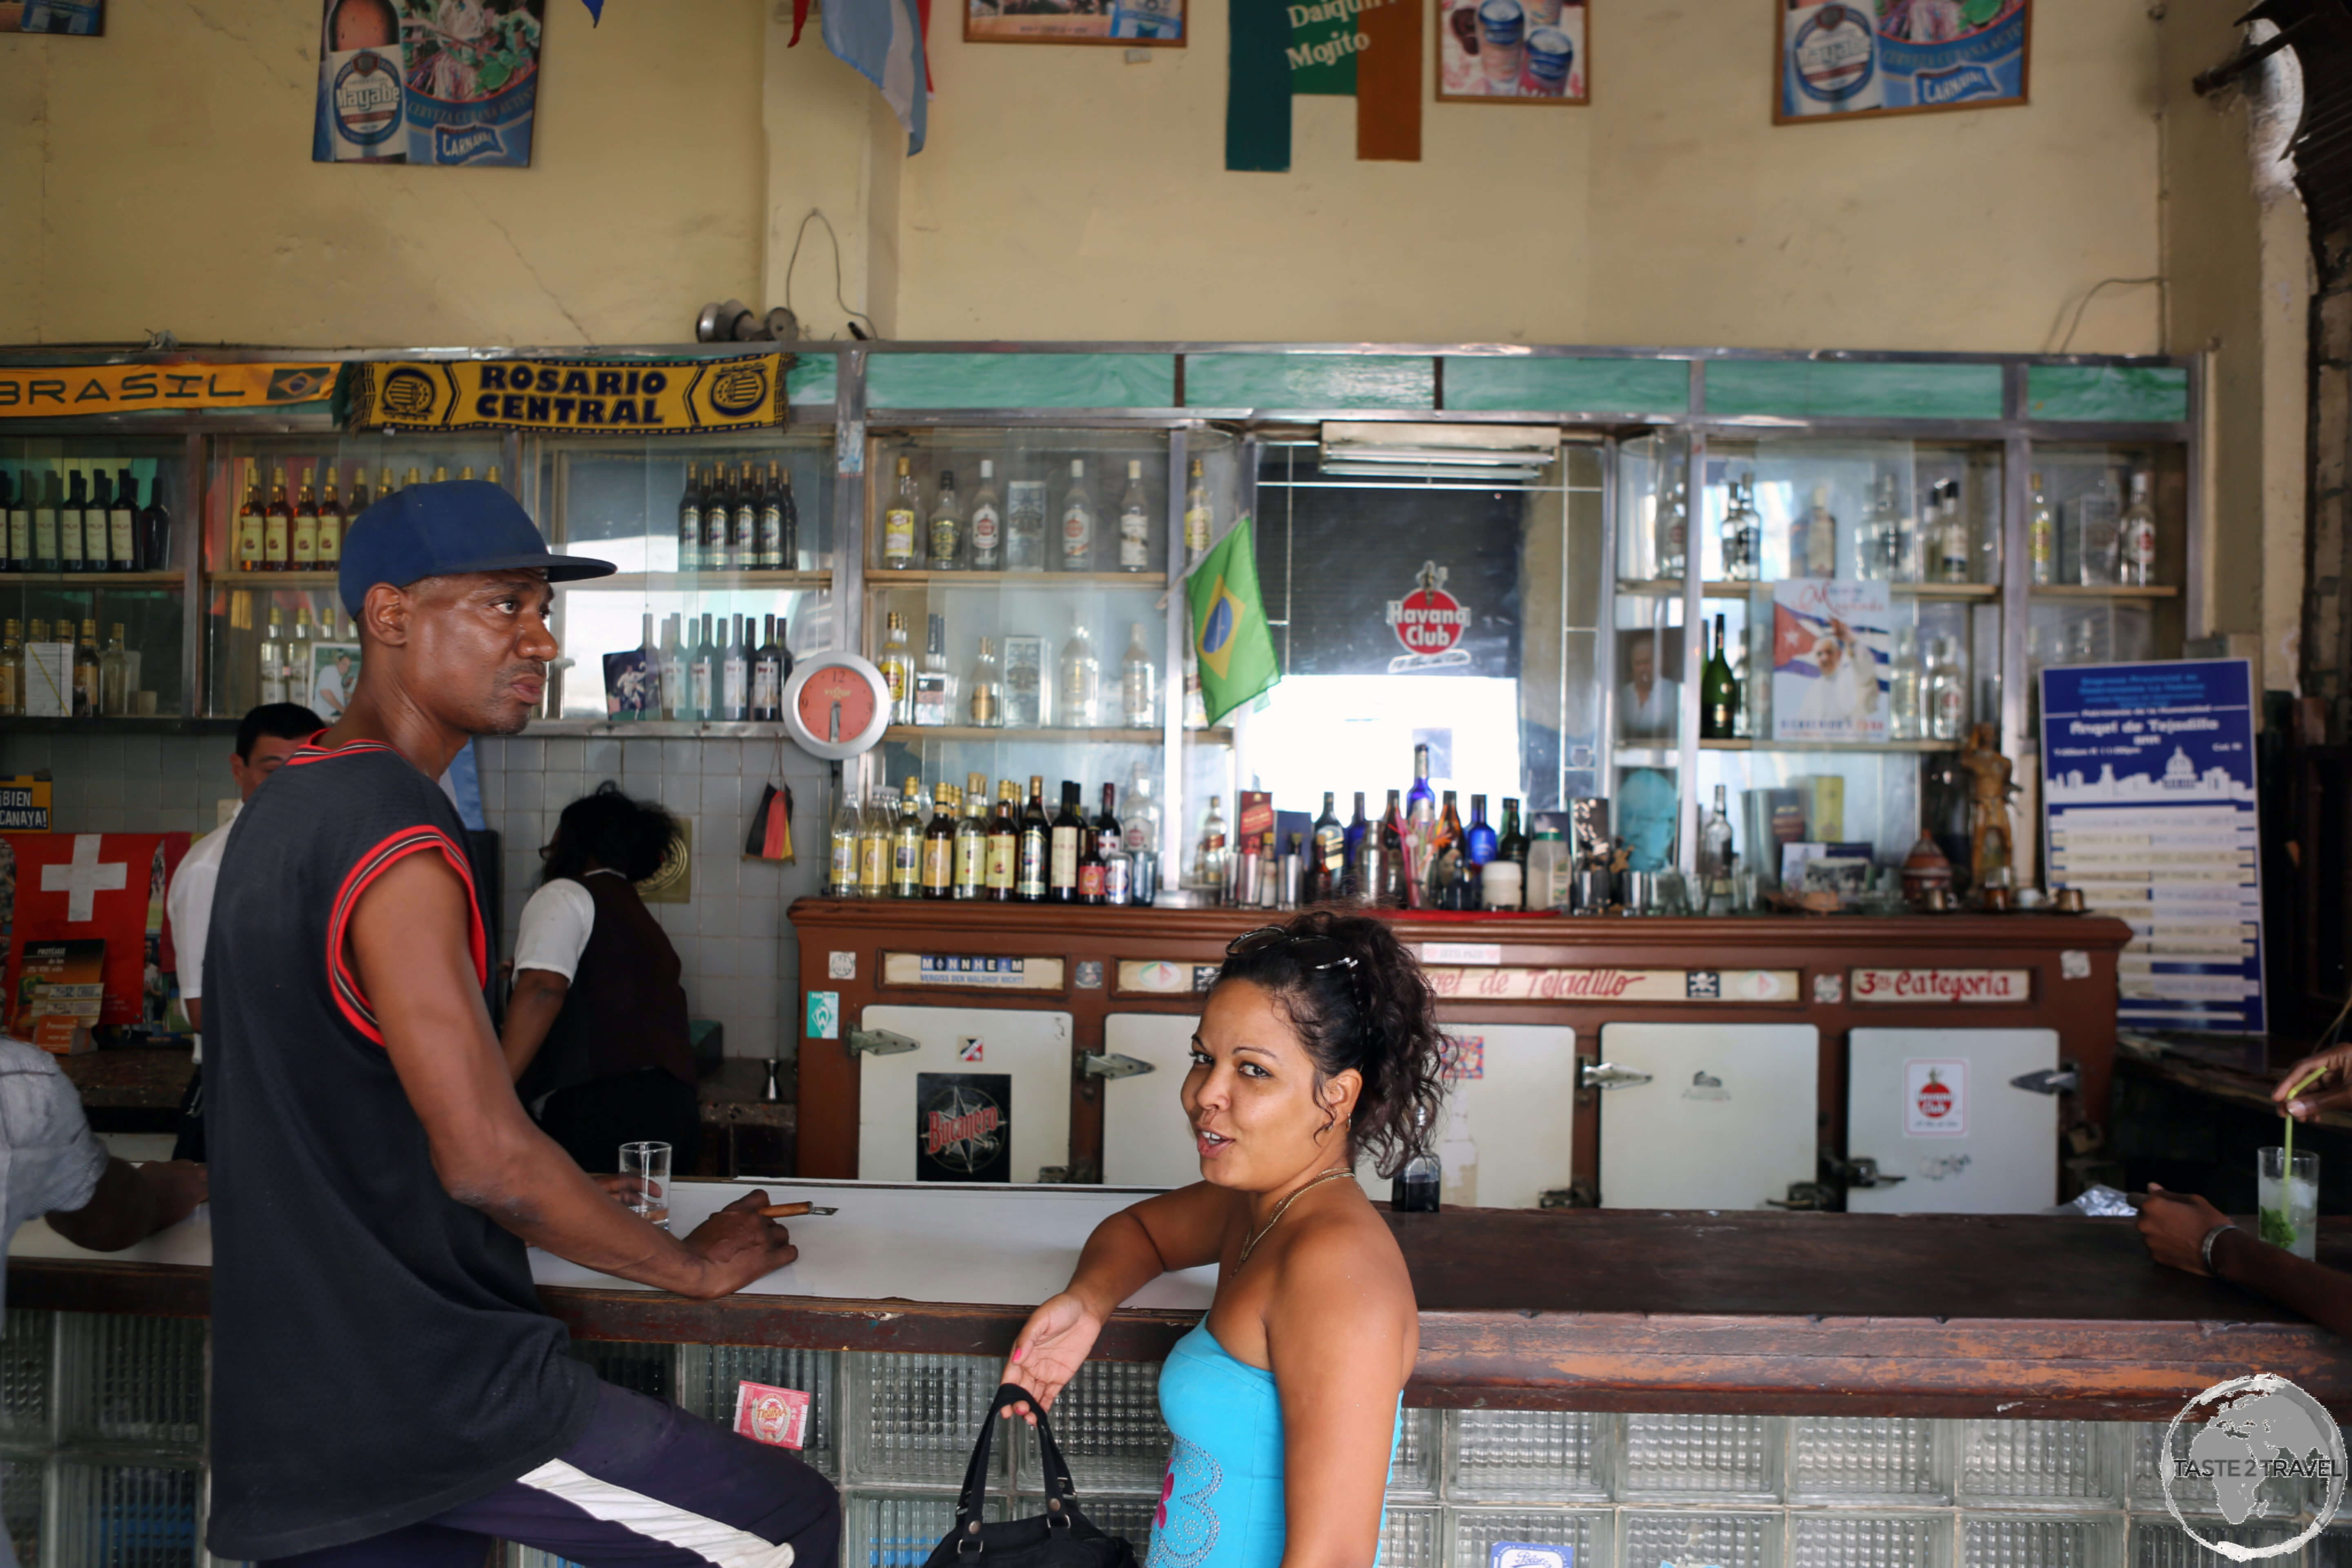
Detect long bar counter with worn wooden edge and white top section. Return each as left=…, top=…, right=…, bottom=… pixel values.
left=7, top=1183, right=2352, bottom=1420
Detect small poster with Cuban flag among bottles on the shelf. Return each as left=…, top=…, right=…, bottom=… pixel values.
left=1771, top=578, right=1893, bottom=740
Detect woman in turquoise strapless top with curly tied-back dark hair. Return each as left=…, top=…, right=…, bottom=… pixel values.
left=1004, top=912, right=1439, bottom=1568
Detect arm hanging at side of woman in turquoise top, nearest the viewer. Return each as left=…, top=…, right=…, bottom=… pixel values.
left=1265, top=1225, right=1418, bottom=1568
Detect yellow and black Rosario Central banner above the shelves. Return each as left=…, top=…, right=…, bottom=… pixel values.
left=350, top=355, right=786, bottom=435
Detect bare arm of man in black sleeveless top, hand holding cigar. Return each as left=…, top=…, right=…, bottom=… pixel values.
left=348, top=853, right=797, bottom=1300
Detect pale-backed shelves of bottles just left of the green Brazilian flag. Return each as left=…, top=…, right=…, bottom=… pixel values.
left=863, top=428, right=1240, bottom=891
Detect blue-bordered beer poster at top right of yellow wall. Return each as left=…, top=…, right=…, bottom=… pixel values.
left=1771, top=0, right=2032, bottom=125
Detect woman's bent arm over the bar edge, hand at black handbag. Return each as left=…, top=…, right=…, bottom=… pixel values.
left=1000, top=1183, right=1232, bottom=1427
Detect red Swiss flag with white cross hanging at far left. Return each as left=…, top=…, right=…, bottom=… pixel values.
left=7, top=832, right=188, bottom=1025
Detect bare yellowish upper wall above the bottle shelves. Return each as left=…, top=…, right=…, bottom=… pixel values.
left=0, top=0, right=2161, bottom=350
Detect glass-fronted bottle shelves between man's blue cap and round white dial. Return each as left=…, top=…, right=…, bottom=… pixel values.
left=539, top=430, right=835, bottom=724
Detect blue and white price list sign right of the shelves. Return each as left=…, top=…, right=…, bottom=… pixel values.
left=2042, top=658, right=2263, bottom=1034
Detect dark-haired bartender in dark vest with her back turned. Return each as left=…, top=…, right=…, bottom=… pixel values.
left=501, top=783, right=701, bottom=1171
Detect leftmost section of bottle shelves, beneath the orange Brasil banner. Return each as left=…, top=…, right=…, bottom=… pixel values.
left=0, top=435, right=188, bottom=722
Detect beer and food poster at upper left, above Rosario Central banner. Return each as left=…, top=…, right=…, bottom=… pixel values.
left=310, top=0, right=546, bottom=167
